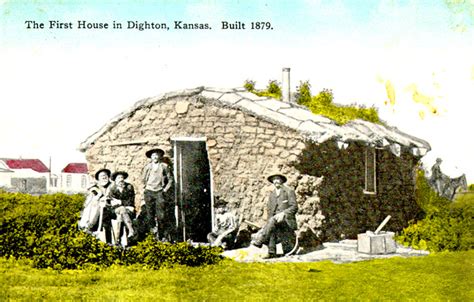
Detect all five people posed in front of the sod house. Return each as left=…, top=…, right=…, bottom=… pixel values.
left=79, top=149, right=298, bottom=258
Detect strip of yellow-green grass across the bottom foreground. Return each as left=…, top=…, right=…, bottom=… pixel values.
left=0, top=250, right=474, bottom=301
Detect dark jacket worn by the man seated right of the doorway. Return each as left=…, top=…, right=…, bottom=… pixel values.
left=268, top=185, right=298, bottom=230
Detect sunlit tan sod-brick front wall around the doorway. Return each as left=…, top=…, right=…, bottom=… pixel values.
left=86, top=96, right=322, bottom=243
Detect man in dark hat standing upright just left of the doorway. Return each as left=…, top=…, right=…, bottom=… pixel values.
left=143, top=148, right=173, bottom=238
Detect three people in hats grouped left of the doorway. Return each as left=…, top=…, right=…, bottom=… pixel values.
left=79, top=149, right=173, bottom=245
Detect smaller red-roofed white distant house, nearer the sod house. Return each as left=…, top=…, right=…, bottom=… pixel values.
left=60, top=163, right=91, bottom=193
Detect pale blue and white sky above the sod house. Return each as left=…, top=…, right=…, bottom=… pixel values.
left=0, top=0, right=474, bottom=183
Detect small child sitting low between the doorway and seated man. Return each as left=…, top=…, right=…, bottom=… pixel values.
left=207, top=198, right=237, bottom=248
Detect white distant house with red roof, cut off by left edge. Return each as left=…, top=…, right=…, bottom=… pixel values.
left=0, top=158, right=50, bottom=194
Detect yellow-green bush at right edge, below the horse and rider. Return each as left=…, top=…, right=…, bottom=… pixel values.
left=397, top=171, right=474, bottom=252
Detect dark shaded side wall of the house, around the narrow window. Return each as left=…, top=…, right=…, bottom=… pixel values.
left=295, top=141, right=421, bottom=240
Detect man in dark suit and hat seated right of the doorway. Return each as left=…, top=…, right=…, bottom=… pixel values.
left=251, top=174, right=298, bottom=258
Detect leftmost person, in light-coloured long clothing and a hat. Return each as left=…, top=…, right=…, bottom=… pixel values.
left=79, top=168, right=112, bottom=243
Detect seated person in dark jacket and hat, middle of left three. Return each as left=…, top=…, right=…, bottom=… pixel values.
left=110, top=171, right=135, bottom=245
